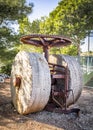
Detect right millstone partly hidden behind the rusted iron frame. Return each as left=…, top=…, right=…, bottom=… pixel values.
left=49, top=55, right=82, bottom=106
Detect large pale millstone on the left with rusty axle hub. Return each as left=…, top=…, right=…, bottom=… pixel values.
left=11, top=51, right=51, bottom=114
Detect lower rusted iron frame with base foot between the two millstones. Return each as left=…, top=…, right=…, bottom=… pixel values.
left=46, top=63, right=75, bottom=113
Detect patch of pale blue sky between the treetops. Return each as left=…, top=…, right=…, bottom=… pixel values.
left=27, top=0, right=60, bottom=22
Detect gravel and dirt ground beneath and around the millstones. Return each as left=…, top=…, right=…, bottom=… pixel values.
left=0, top=79, right=93, bottom=130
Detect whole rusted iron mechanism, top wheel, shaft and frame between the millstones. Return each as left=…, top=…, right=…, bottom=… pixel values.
left=17, top=34, right=80, bottom=114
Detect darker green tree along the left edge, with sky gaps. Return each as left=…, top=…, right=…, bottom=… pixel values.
left=0, top=0, right=33, bottom=74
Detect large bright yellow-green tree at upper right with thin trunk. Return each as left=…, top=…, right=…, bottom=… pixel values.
left=41, top=0, right=93, bottom=55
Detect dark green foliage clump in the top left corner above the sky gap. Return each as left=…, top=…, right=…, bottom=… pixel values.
left=0, top=0, right=33, bottom=21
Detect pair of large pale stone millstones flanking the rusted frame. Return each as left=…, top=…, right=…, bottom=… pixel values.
left=11, top=51, right=82, bottom=115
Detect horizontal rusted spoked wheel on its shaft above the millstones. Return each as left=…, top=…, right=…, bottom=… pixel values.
left=20, top=34, right=71, bottom=61
